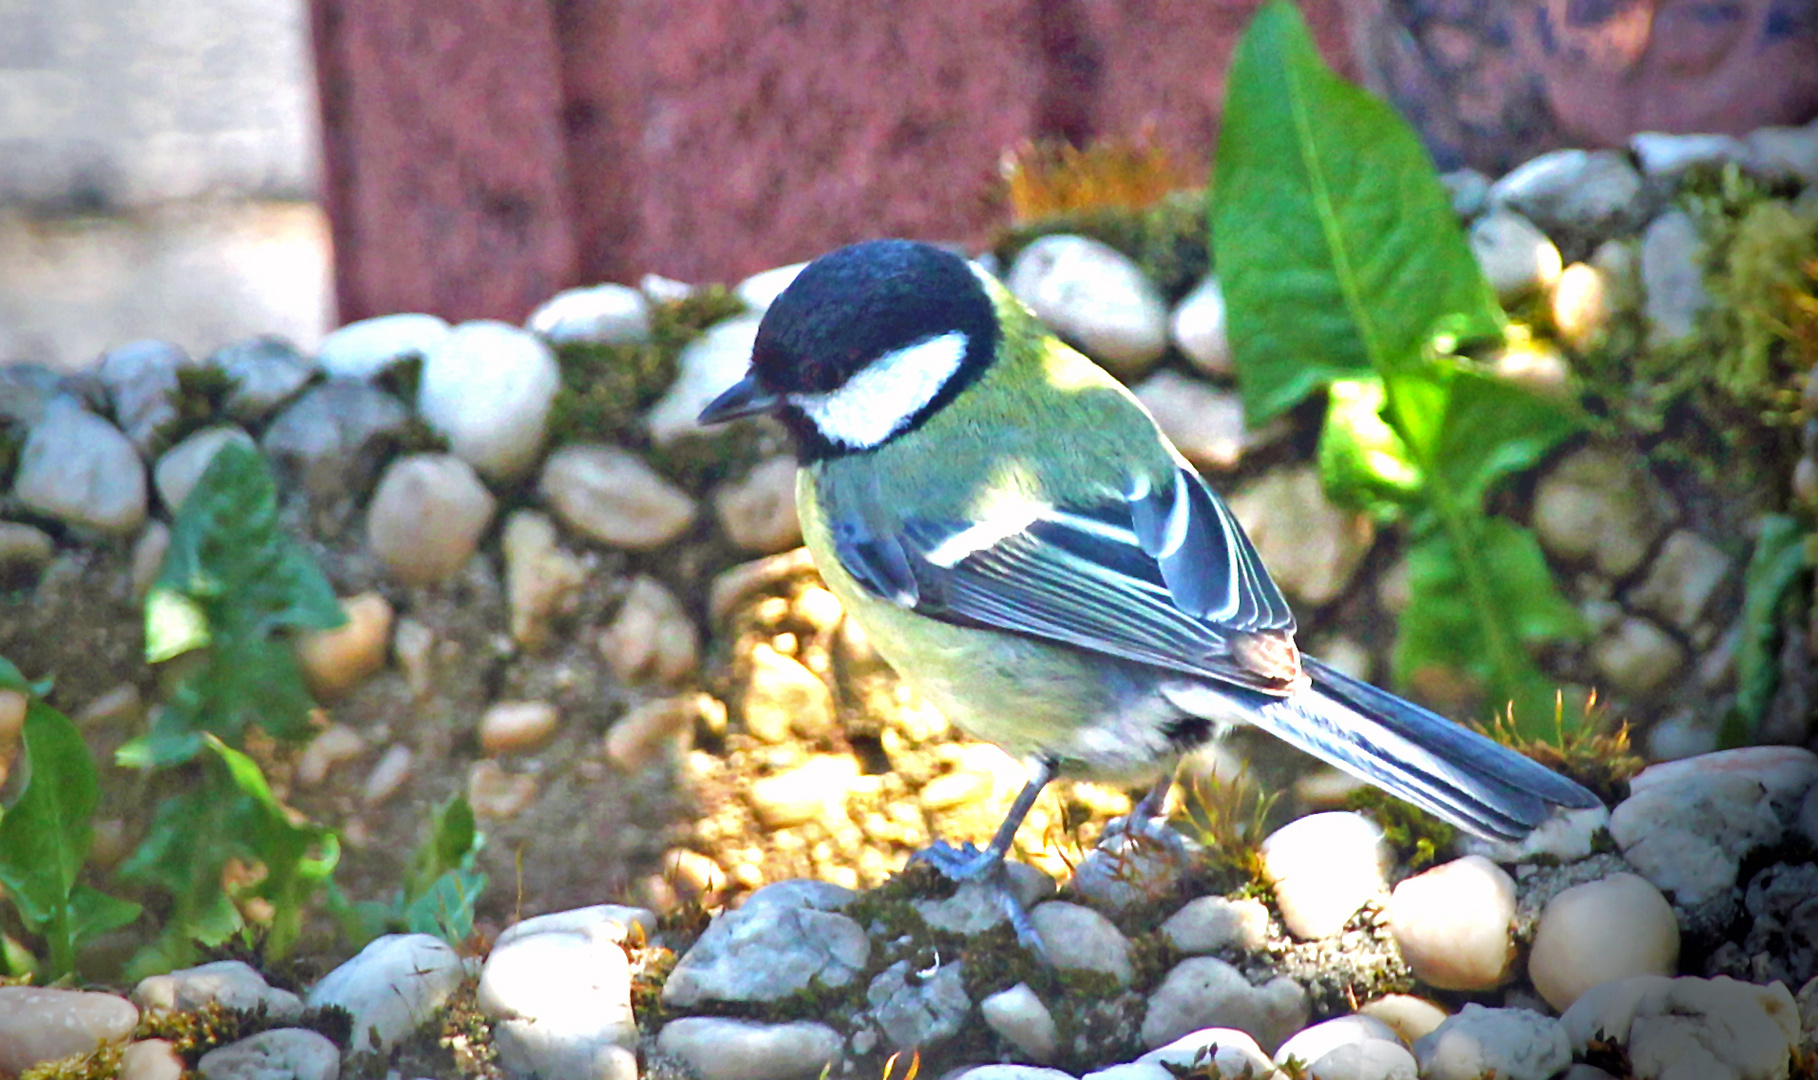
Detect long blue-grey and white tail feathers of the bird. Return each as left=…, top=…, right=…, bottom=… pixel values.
left=1207, top=656, right=1600, bottom=840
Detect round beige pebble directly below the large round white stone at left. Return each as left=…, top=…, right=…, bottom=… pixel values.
left=363, top=451, right=498, bottom=585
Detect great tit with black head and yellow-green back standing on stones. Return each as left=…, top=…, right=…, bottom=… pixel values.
left=700, top=240, right=1598, bottom=944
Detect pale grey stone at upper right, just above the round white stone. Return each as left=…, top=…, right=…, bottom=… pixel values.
left=1489, top=149, right=1643, bottom=245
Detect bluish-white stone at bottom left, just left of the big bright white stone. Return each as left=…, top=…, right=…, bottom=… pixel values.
left=304, top=935, right=467, bottom=1051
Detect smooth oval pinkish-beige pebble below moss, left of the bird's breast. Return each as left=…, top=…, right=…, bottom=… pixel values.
left=538, top=444, right=694, bottom=551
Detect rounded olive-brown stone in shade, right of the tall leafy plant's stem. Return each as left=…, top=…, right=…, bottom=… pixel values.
left=1534, top=445, right=1665, bottom=578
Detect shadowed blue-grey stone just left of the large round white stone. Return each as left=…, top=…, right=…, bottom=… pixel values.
left=260, top=378, right=411, bottom=502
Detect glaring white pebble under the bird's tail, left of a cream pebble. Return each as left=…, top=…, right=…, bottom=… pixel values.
left=1260, top=811, right=1389, bottom=940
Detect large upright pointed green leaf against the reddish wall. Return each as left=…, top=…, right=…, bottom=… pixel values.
left=1211, top=0, right=1503, bottom=427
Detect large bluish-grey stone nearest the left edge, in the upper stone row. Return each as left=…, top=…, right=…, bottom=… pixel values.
left=13, top=398, right=145, bottom=533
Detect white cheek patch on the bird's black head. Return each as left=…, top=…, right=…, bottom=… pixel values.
left=789, top=331, right=969, bottom=449
